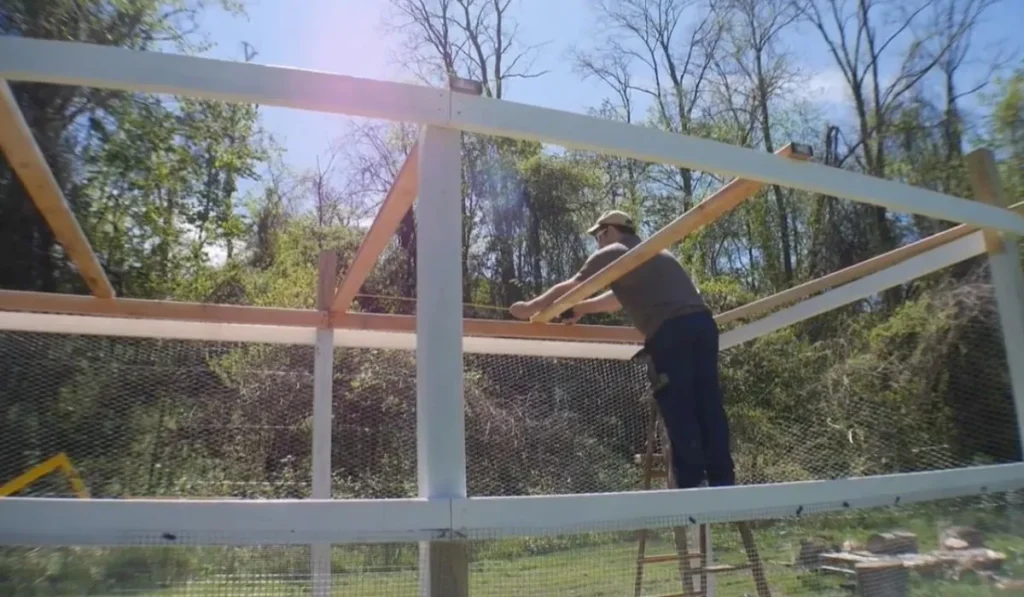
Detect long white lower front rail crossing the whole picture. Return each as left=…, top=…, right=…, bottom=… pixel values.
left=0, top=464, right=1024, bottom=546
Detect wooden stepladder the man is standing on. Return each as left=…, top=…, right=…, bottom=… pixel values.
left=634, top=399, right=771, bottom=597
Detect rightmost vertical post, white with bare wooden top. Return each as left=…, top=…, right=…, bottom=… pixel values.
left=967, top=148, right=1024, bottom=451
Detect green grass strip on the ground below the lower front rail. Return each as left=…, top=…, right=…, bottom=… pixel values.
left=8, top=505, right=1024, bottom=597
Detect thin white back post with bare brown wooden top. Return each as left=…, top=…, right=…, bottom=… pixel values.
left=310, top=251, right=338, bottom=597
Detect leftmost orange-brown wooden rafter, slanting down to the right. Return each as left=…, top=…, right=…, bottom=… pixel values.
left=0, top=80, right=114, bottom=299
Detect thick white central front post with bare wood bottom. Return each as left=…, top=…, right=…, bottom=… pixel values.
left=416, top=127, right=469, bottom=597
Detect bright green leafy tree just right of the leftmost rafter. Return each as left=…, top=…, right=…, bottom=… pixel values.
left=76, top=96, right=266, bottom=297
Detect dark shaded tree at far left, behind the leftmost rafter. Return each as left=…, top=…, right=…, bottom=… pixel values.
left=0, top=0, right=242, bottom=292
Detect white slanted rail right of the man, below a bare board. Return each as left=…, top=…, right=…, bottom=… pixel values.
left=719, top=231, right=985, bottom=350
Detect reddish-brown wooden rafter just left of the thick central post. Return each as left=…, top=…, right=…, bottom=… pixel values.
left=331, top=143, right=420, bottom=312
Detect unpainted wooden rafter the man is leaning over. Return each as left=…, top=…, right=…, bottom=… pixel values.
left=530, top=143, right=811, bottom=323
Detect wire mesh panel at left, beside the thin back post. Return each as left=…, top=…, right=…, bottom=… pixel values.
left=0, top=332, right=312, bottom=498
